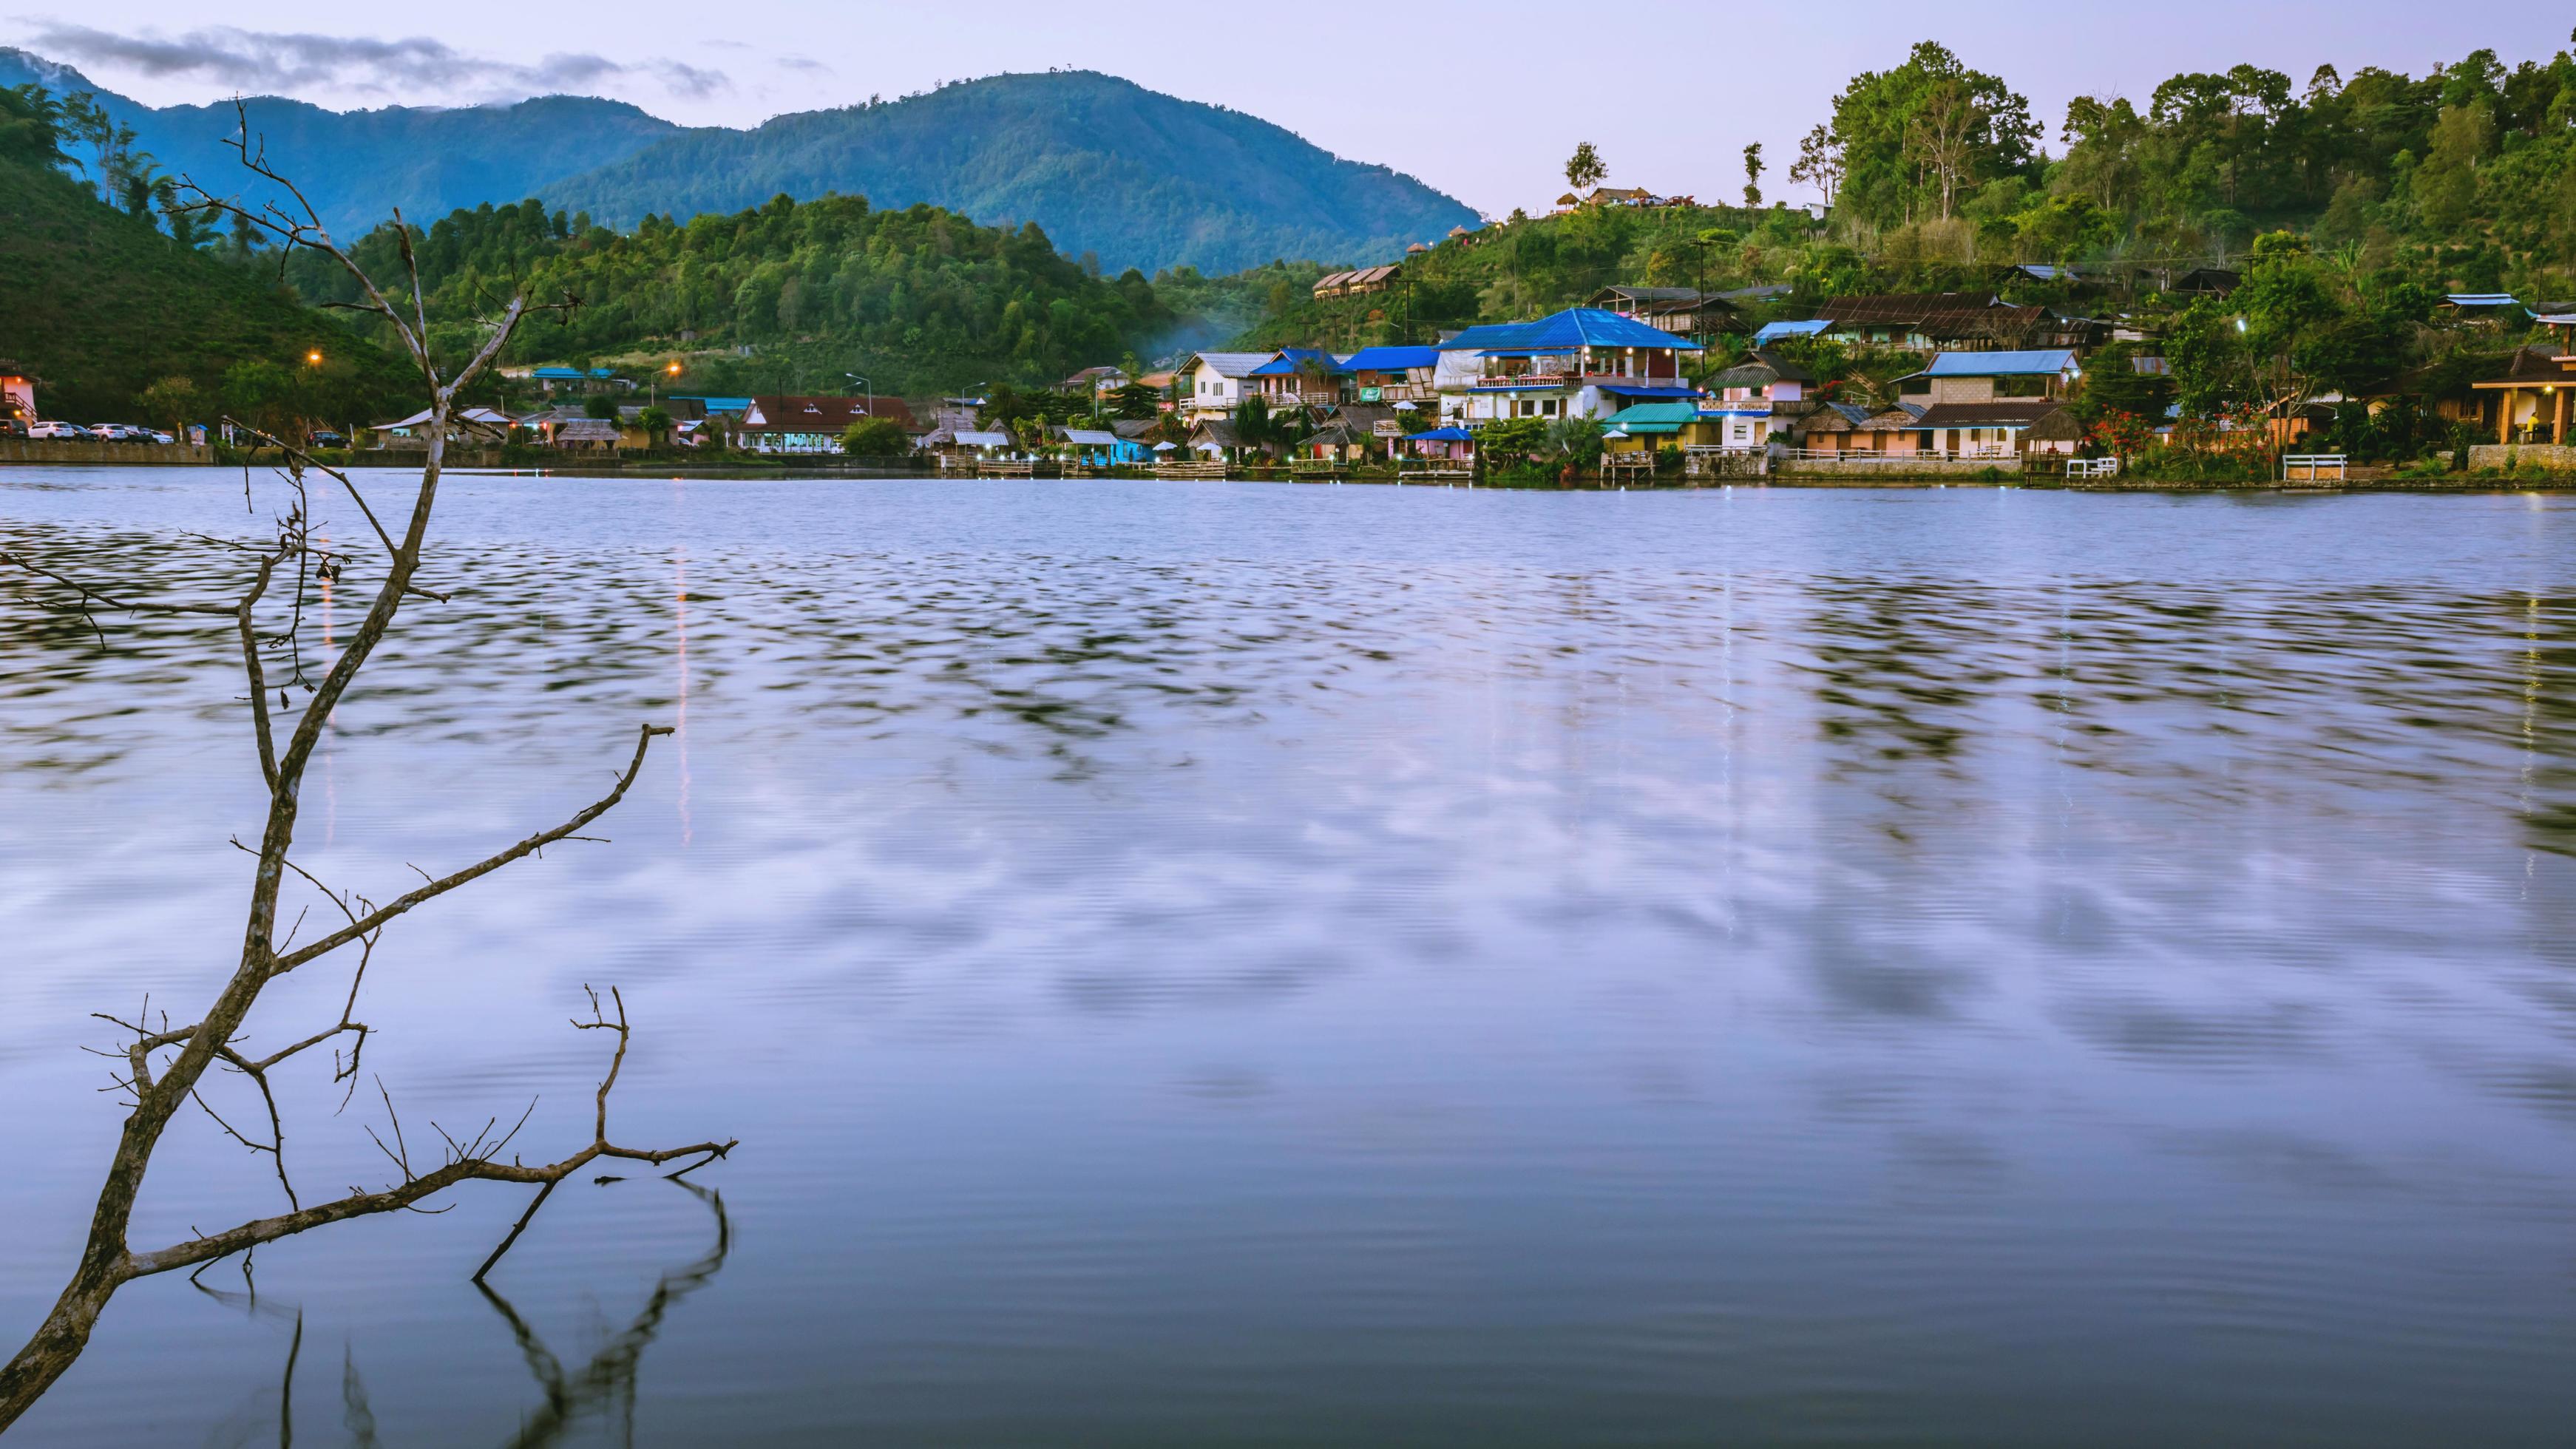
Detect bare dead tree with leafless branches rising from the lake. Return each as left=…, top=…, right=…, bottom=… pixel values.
left=0, top=113, right=734, bottom=1431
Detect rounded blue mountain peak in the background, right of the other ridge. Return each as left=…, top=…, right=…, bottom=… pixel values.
left=538, top=72, right=1476, bottom=273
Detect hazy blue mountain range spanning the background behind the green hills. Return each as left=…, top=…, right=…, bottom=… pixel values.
left=0, top=49, right=1476, bottom=273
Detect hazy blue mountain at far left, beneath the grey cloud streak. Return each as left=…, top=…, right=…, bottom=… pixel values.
left=0, top=49, right=680, bottom=237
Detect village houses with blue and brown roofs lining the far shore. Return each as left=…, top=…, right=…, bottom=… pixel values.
left=316, top=240, right=2576, bottom=479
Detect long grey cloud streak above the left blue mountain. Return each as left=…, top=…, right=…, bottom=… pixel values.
left=28, top=21, right=734, bottom=101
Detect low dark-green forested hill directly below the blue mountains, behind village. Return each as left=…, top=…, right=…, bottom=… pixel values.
left=288, top=196, right=1180, bottom=394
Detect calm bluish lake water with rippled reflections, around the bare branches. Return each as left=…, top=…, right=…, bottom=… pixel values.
left=0, top=469, right=2576, bottom=1444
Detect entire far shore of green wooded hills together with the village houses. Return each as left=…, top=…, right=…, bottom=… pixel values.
left=0, top=41, right=2576, bottom=481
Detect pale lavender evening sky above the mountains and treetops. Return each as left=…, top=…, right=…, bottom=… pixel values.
left=0, top=0, right=2576, bottom=216
